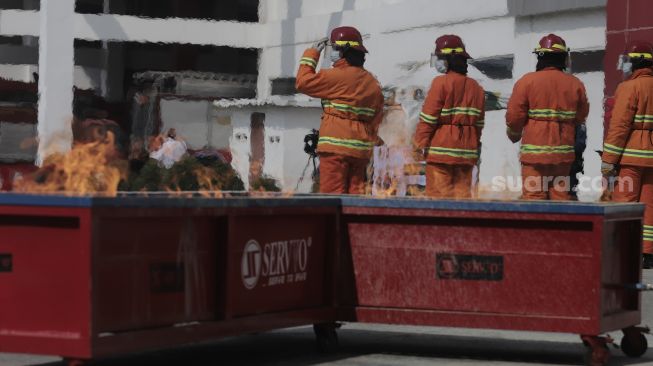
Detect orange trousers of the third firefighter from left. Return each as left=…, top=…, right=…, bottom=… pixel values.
left=521, top=164, right=571, bottom=201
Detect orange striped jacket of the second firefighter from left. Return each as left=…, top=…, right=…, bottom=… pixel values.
left=413, top=71, right=485, bottom=165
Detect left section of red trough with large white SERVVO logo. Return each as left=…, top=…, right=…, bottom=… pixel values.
left=0, top=195, right=339, bottom=359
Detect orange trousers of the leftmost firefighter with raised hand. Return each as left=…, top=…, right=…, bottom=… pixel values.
left=320, top=153, right=369, bottom=194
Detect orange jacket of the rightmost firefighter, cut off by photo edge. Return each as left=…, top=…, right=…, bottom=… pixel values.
left=603, top=68, right=653, bottom=167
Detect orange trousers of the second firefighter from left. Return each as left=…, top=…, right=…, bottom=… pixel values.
left=426, top=163, right=474, bottom=199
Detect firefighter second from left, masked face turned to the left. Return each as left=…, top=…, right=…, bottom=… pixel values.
left=413, top=35, right=485, bottom=198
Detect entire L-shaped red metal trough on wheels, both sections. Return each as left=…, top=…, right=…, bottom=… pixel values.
left=0, top=195, right=645, bottom=360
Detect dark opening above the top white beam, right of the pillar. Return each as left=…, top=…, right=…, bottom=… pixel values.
left=76, top=0, right=259, bottom=22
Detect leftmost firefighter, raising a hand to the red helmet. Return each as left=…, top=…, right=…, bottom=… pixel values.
left=296, top=27, right=383, bottom=194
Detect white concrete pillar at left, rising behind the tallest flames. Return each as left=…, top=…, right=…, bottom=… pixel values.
left=36, top=0, right=75, bottom=165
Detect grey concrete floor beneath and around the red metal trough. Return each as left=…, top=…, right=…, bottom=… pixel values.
left=0, top=270, right=653, bottom=366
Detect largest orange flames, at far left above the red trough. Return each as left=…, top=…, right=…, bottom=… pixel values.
left=14, top=132, right=127, bottom=196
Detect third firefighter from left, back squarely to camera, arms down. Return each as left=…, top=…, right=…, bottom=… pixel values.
left=506, top=34, right=589, bottom=200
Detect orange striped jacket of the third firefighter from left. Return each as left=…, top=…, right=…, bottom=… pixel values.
left=506, top=67, right=589, bottom=165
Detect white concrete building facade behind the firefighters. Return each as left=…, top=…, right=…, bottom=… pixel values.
left=0, top=0, right=606, bottom=200
